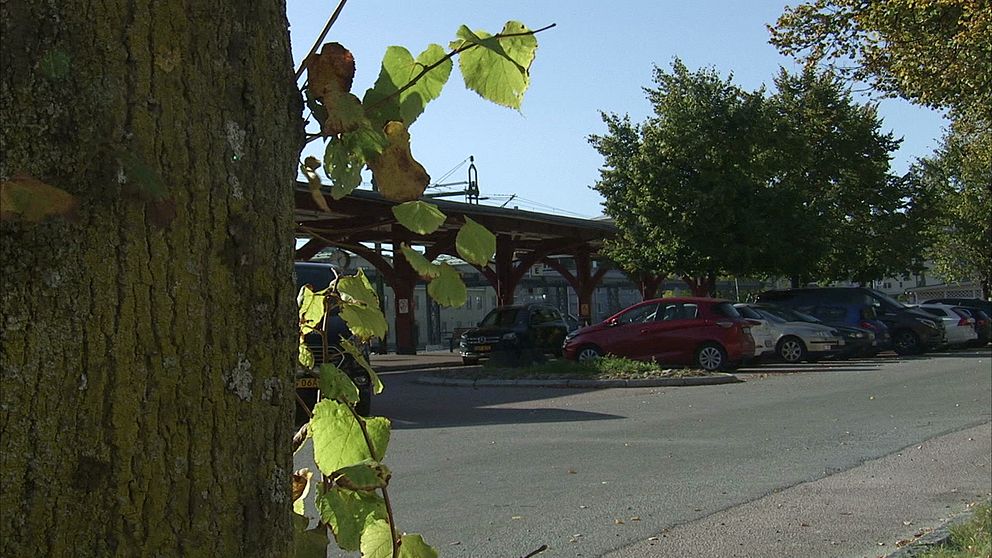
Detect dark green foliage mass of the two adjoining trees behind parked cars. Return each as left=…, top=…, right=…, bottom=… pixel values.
left=590, top=60, right=919, bottom=294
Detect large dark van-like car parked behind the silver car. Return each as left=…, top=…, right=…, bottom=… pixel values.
left=758, top=287, right=945, bottom=355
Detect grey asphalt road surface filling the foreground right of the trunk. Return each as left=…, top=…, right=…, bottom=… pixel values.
left=299, top=348, right=992, bottom=558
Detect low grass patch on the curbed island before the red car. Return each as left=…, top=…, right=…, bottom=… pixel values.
left=457, top=356, right=711, bottom=380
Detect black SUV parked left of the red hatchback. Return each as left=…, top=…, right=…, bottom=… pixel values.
left=458, top=303, right=568, bottom=364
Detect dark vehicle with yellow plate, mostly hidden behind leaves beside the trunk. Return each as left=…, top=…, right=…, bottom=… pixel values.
left=293, top=262, right=372, bottom=425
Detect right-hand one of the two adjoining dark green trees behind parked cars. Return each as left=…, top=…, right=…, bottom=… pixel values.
left=761, top=69, right=921, bottom=283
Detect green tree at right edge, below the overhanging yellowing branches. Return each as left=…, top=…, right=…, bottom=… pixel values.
left=911, top=123, right=992, bottom=299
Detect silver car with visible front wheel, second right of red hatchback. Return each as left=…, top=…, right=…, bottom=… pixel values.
left=747, top=304, right=845, bottom=364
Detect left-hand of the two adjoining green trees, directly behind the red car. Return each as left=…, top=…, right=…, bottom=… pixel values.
left=590, top=60, right=767, bottom=295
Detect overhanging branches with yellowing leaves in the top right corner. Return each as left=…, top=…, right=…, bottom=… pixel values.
left=770, top=0, right=992, bottom=120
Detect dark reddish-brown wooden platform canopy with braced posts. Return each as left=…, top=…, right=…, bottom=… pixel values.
left=296, top=183, right=616, bottom=354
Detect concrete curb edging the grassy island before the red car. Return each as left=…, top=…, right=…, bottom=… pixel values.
left=414, top=373, right=742, bottom=389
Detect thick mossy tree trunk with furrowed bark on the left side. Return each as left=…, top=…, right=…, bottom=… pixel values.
left=0, top=0, right=302, bottom=556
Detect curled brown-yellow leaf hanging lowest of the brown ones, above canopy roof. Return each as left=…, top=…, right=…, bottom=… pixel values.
left=368, top=121, right=431, bottom=202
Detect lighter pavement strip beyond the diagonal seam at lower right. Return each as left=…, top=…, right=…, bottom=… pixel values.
left=606, top=423, right=992, bottom=558
